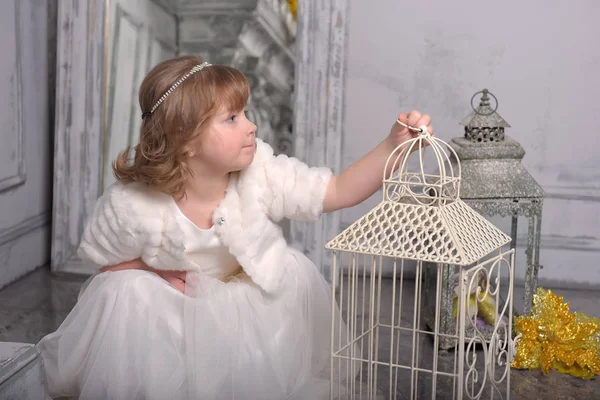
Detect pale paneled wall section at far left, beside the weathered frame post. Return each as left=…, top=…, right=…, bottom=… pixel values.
left=0, top=0, right=55, bottom=287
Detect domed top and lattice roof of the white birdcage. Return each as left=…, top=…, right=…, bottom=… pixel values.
left=326, top=131, right=511, bottom=265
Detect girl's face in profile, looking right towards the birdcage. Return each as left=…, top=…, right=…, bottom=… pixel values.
left=197, top=108, right=256, bottom=173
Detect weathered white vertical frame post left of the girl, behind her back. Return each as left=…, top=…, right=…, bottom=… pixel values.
left=51, top=0, right=107, bottom=272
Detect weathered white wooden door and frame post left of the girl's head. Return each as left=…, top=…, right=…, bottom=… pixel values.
left=51, top=0, right=177, bottom=274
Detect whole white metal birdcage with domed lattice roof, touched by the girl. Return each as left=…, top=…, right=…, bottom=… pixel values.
left=326, top=130, right=515, bottom=399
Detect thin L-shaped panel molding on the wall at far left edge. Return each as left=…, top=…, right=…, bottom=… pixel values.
left=0, top=0, right=27, bottom=193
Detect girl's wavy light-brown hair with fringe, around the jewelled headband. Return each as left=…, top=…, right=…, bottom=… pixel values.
left=112, top=56, right=250, bottom=196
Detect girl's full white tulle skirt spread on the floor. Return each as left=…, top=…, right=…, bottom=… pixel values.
left=38, top=249, right=356, bottom=400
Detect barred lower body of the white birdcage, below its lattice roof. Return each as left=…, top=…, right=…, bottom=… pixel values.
left=332, top=250, right=515, bottom=400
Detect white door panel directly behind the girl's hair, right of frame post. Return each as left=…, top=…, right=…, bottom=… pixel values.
left=102, top=0, right=177, bottom=188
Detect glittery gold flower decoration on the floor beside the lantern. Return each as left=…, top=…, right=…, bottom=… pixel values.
left=512, top=288, right=600, bottom=379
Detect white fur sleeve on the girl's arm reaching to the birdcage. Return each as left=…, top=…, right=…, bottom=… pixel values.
left=261, top=143, right=332, bottom=221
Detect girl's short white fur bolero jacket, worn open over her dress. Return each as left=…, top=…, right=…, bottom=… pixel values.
left=78, top=139, right=332, bottom=292
